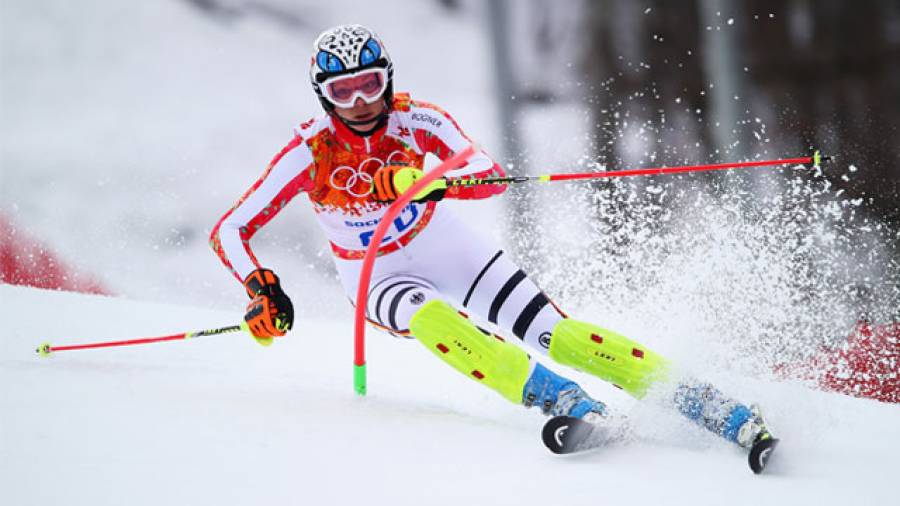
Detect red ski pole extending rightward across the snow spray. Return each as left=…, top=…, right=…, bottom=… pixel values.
left=446, top=151, right=831, bottom=188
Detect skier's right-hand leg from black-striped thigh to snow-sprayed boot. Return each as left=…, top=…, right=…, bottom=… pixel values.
left=420, top=233, right=765, bottom=446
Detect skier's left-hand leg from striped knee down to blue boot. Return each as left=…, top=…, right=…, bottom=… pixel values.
left=367, top=275, right=605, bottom=418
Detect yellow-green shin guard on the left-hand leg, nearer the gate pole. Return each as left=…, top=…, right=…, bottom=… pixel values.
left=409, top=300, right=529, bottom=404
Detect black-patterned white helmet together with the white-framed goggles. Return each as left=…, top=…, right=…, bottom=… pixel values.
left=309, top=25, right=394, bottom=113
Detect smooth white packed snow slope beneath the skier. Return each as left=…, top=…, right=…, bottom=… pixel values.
left=0, top=285, right=900, bottom=506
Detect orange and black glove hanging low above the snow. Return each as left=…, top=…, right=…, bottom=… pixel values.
left=244, top=269, right=294, bottom=346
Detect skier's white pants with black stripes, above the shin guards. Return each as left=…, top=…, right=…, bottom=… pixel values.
left=335, top=206, right=563, bottom=355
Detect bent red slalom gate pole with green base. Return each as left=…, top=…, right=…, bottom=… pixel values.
left=353, top=144, right=480, bottom=395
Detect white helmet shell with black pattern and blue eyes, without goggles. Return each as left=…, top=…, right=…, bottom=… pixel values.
left=309, top=25, right=394, bottom=112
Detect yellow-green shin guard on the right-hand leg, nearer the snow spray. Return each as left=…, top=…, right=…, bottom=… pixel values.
left=550, top=318, right=668, bottom=399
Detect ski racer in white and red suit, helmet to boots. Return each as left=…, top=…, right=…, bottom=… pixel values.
left=210, top=25, right=771, bottom=462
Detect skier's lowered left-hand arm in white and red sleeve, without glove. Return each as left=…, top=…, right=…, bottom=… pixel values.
left=209, top=136, right=313, bottom=283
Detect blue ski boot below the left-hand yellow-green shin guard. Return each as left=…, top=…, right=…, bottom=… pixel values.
left=522, top=363, right=606, bottom=422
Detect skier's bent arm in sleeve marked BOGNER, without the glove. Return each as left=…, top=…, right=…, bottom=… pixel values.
left=410, top=101, right=506, bottom=199
